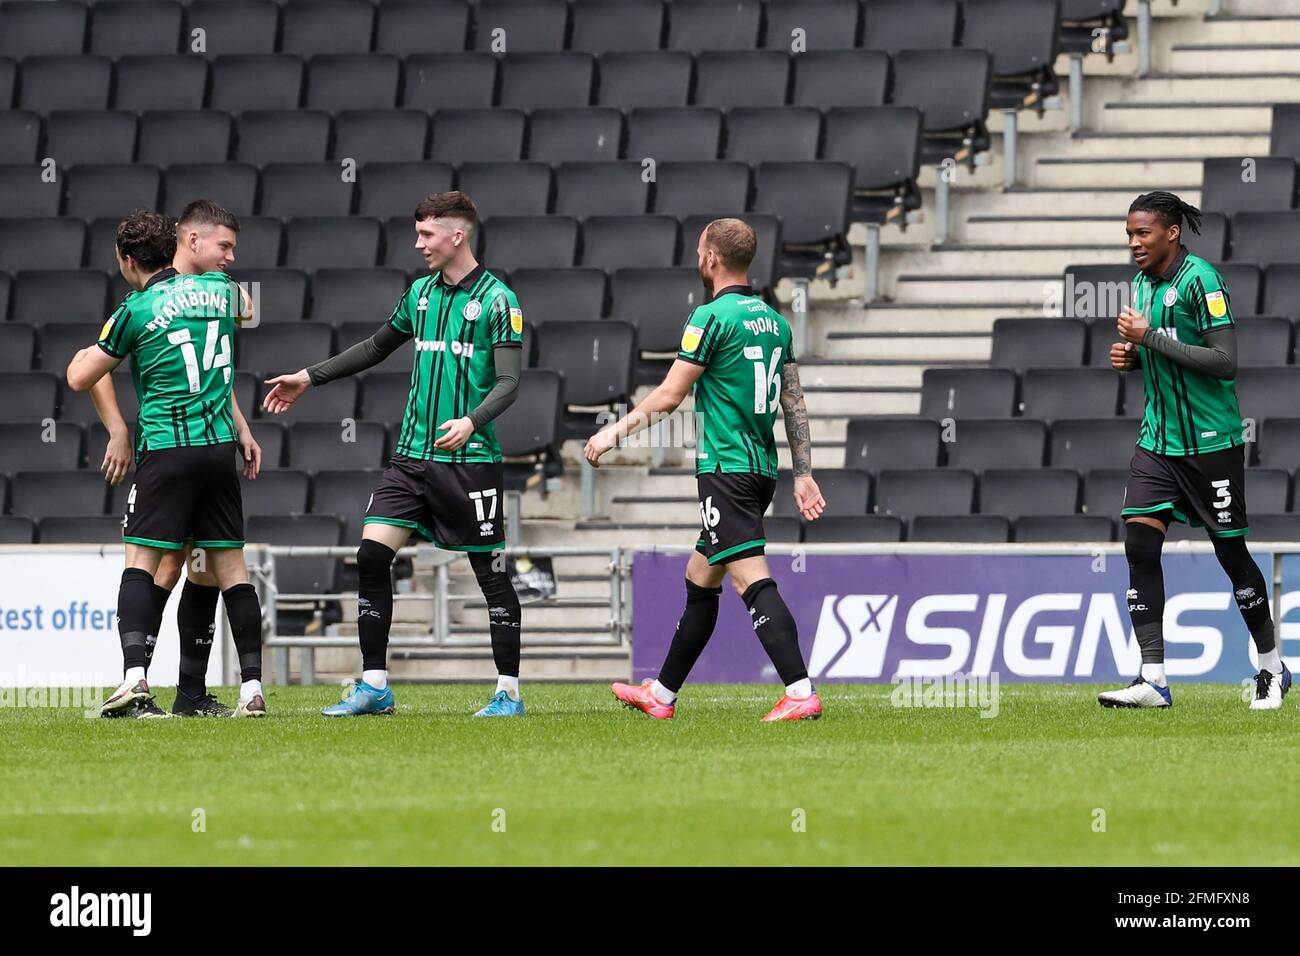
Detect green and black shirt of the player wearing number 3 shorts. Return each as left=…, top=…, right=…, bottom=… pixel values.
left=1132, top=246, right=1244, bottom=455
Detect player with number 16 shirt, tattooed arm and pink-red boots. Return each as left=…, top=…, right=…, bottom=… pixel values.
left=585, top=219, right=826, bottom=721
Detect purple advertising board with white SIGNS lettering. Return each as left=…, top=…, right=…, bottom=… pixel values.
left=632, top=551, right=1274, bottom=683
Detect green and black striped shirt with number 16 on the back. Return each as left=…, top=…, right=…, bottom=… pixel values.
left=677, top=286, right=794, bottom=479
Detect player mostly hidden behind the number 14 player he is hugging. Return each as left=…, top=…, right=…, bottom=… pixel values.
left=91, top=199, right=261, bottom=717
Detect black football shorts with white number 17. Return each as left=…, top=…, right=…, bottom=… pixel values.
left=365, top=455, right=506, bottom=551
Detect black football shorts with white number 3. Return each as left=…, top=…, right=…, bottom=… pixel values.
left=1119, top=445, right=1249, bottom=537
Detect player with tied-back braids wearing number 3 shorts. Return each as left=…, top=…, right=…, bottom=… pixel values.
left=1099, top=193, right=1291, bottom=710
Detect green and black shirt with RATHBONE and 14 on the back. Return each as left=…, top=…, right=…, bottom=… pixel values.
left=99, top=269, right=242, bottom=459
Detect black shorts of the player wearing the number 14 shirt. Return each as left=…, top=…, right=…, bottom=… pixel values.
left=122, top=441, right=244, bottom=551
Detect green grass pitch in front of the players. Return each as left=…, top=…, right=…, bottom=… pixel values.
left=0, top=684, right=1300, bottom=866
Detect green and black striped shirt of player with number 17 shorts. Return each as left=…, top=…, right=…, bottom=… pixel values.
left=389, top=265, right=524, bottom=462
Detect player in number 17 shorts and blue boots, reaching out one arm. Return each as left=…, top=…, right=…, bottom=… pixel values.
left=263, top=191, right=524, bottom=717
